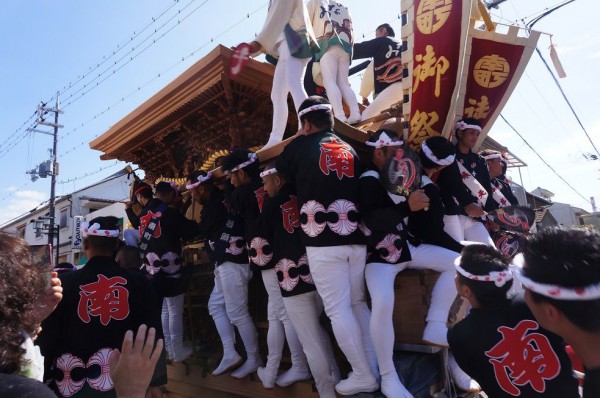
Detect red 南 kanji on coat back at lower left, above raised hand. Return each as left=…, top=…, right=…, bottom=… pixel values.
left=77, top=274, right=129, bottom=326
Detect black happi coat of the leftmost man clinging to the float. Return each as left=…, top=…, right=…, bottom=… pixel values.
left=139, top=198, right=198, bottom=297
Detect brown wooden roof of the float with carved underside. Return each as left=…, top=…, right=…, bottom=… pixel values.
left=90, top=45, right=297, bottom=178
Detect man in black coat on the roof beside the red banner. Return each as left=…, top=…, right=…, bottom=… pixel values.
left=352, top=24, right=403, bottom=120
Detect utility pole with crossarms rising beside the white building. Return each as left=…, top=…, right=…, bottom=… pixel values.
left=27, top=93, right=64, bottom=259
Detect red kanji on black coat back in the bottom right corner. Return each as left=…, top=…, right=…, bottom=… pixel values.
left=486, top=319, right=560, bottom=396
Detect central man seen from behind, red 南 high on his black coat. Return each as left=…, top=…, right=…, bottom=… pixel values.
left=276, top=96, right=379, bottom=395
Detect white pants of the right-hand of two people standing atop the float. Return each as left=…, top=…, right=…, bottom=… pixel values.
left=319, top=45, right=360, bottom=121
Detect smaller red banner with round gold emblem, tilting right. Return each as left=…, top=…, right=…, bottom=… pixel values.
left=457, top=23, right=540, bottom=148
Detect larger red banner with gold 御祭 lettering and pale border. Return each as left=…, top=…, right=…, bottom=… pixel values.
left=402, top=0, right=471, bottom=148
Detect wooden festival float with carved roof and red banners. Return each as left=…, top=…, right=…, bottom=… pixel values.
left=90, top=0, right=540, bottom=398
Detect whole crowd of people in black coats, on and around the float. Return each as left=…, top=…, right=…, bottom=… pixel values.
left=0, top=0, right=600, bottom=398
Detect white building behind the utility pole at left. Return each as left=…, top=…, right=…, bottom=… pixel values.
left=0, top=170, right=130, bottom=264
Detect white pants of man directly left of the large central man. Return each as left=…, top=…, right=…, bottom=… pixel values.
left=283, top=291, right=337, bottom=398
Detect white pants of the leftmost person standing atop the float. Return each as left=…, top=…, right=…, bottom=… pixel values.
left=269, top=40, right=310, bottom=143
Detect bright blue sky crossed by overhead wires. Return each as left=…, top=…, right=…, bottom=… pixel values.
left=0, top=0, right=600, bottom=222
